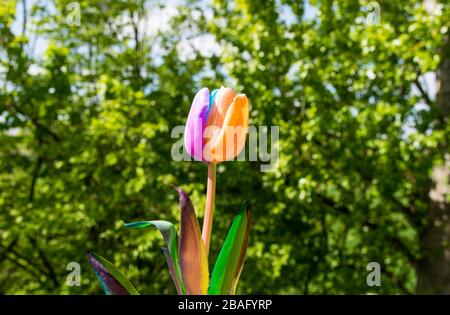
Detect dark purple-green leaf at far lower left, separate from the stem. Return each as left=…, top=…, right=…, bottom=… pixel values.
left=88, top=252, right=139, bottom=295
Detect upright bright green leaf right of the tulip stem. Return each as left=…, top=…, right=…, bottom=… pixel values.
left=208, top=200, right=252, bottom=294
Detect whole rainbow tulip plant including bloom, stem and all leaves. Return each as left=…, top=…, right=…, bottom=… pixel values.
left=88, top=87, right=252, bottom=295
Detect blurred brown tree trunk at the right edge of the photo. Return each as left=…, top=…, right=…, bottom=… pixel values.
left=417, top=30, right=450, bottom=294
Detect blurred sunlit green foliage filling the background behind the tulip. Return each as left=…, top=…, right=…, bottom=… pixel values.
left=0, top=0, right=450, bottom=294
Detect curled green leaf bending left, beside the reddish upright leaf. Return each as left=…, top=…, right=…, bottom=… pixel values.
left=125, top=220, right=186, bottom=295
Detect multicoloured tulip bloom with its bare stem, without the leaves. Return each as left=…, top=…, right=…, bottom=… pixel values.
left=184, top=87, right=249, bottom=253
